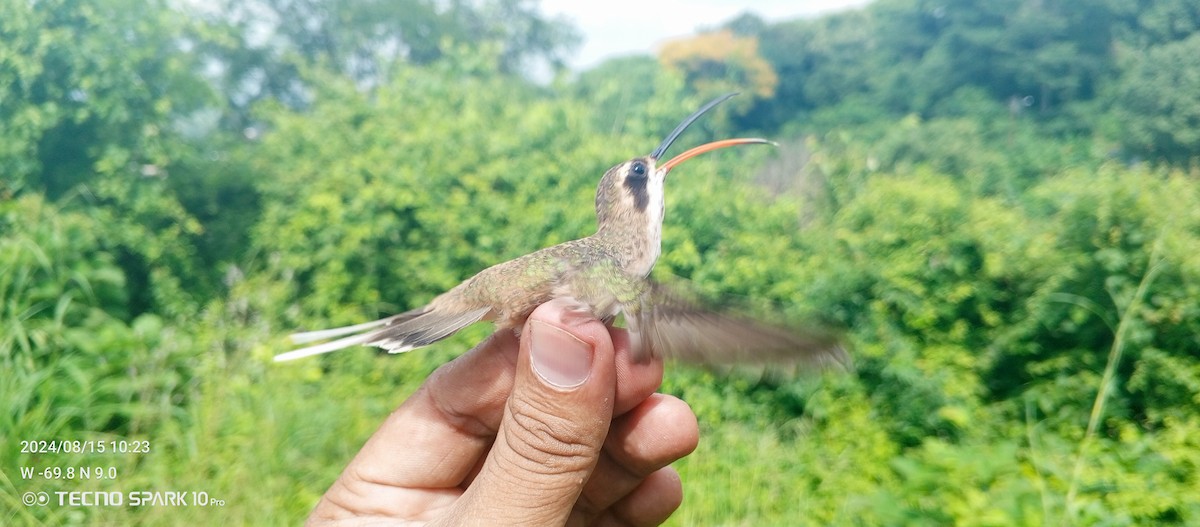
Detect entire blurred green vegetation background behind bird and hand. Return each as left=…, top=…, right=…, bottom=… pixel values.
left=0, top=0, right=1200, bottom=526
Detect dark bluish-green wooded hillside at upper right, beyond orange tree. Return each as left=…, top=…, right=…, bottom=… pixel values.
left=726, top=0, right=1200, bottom=164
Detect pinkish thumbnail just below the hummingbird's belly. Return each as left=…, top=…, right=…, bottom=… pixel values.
left=529, top=321, right=593, bottom=388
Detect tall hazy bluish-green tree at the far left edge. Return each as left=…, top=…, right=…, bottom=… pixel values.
left=0, top=0, right=224, bottom=317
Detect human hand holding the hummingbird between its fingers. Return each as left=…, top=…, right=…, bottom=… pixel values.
left=308, top=300, right=698, bottom=526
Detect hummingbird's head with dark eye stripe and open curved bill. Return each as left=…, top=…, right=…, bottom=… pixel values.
left=596, top=94, right=774, bottom=275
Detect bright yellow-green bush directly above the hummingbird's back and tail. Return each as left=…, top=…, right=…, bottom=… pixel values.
left=256, top=70, right=604, bottom=326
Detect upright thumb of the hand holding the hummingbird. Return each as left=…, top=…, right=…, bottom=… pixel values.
left=451, top=299, right=617, bottom=525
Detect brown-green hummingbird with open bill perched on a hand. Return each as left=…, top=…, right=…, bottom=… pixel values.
left=275, top=94, right=850, bottom=370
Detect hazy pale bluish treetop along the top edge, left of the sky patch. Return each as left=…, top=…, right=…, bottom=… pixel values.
left=189, top=0, right=578, bottom=130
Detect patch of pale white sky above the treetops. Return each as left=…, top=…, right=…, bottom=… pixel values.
left=541, top=0, right=869, bottom=70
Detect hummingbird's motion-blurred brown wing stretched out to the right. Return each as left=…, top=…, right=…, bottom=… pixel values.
left=625, top=283, right=853, bottom=371
